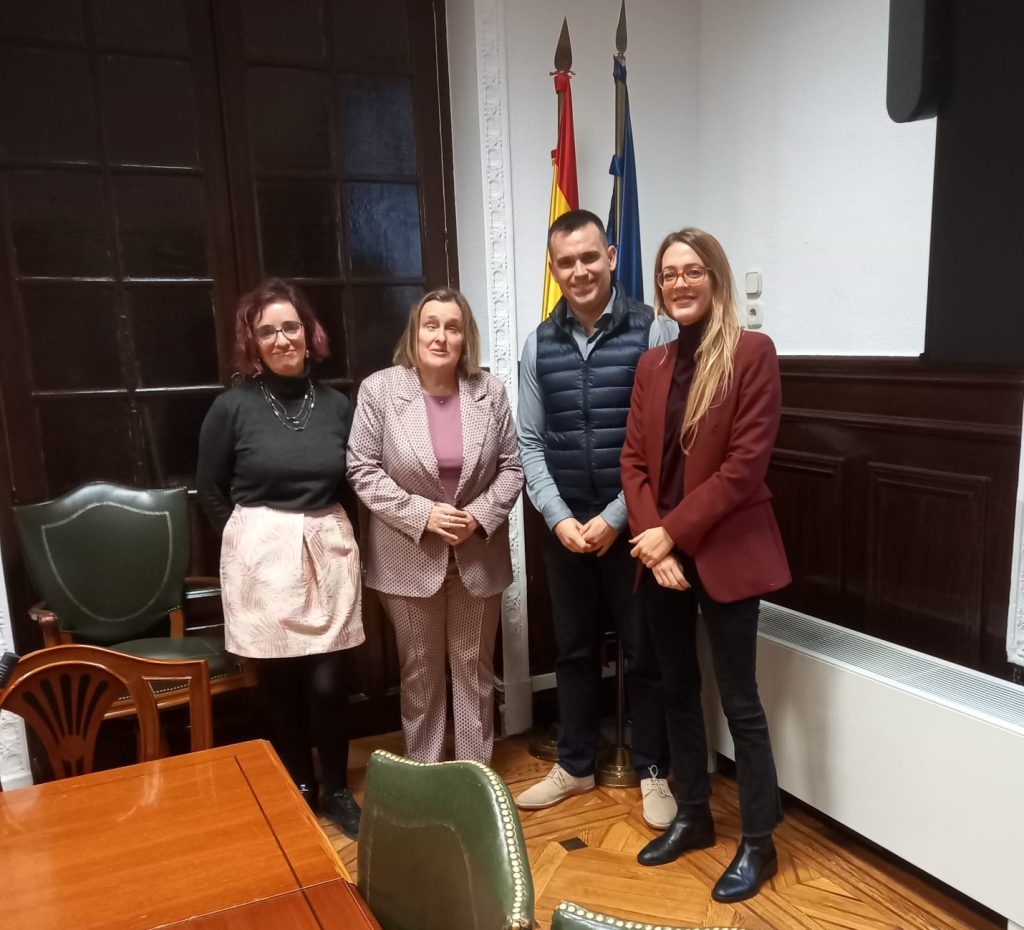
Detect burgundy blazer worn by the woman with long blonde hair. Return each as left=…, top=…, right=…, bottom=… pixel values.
left=622, top=330, right=792, bottom=603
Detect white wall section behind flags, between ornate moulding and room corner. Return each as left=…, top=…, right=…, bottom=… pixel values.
left=505, top=0, right=699, bottom=345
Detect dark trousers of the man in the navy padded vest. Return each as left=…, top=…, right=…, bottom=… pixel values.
left=544, top=534, right=669, bottom=778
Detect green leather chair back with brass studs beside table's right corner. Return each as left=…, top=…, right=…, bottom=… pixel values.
left=358, top=751, right=534, bottom=930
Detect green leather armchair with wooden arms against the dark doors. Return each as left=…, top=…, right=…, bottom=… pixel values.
left=14, top=481, right=255, bottom=717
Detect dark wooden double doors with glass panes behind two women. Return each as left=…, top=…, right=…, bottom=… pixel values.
left=0, top=0, right=458, bottom=731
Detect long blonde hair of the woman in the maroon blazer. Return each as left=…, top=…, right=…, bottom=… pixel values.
left=654, top=226, right=740, bottom=452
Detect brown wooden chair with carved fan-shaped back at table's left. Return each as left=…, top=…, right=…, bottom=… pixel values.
left=0, top=645, right=213, bottom=791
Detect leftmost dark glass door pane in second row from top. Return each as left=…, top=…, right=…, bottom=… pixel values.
left=0, top=48, right=97, bottom=162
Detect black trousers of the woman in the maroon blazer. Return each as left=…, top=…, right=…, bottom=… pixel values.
left=641, top=553, right=782, bottom=837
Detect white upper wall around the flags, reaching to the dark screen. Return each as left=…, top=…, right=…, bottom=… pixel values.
left=447, top=0, right=935, bottom=355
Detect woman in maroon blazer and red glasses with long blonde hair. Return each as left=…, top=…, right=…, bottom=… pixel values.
left=622, top=228, right=790, bottom=901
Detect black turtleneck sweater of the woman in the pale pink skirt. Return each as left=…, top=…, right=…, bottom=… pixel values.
left=196, top=372, right=352, bottom=533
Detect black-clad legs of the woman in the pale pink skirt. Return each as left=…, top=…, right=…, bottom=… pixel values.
left=259, top=652, right=348, bottom=794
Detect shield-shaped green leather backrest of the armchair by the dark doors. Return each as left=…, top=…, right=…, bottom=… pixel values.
left=14, top=481, right=188, bottom=645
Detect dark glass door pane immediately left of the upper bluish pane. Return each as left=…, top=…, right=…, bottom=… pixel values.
left=249, top=68, right=331, bottom=168
